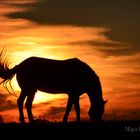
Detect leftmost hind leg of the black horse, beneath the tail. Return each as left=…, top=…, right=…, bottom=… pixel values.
left=17, top=90, right=26, bottom=123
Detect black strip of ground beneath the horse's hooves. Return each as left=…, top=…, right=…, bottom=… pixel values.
left=0, top=120, right=140, bottom=139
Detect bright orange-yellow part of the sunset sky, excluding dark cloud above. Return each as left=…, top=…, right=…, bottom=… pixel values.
left=0, top=0, right=140, bottom=120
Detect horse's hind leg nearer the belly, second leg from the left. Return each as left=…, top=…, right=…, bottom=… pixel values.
left=25, top=92, right=35, bottom=123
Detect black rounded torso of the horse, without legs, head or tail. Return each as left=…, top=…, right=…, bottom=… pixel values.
left=17, top=57, right=95, bottom=92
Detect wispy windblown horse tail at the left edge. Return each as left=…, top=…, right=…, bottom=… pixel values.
left=0, top=49, right=17, bottom=96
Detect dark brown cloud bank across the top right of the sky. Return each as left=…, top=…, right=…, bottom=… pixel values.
left=7, top=0, right=140, bottom=47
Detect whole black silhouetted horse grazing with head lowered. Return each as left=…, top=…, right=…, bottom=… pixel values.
left=0, top=49, right=106, bottom=123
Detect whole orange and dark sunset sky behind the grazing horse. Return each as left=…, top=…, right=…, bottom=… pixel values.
left=0, top=0, right=140, bottom=122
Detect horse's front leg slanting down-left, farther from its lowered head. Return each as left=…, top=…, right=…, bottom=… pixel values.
left=63, top=96, right=73, bottom=122
